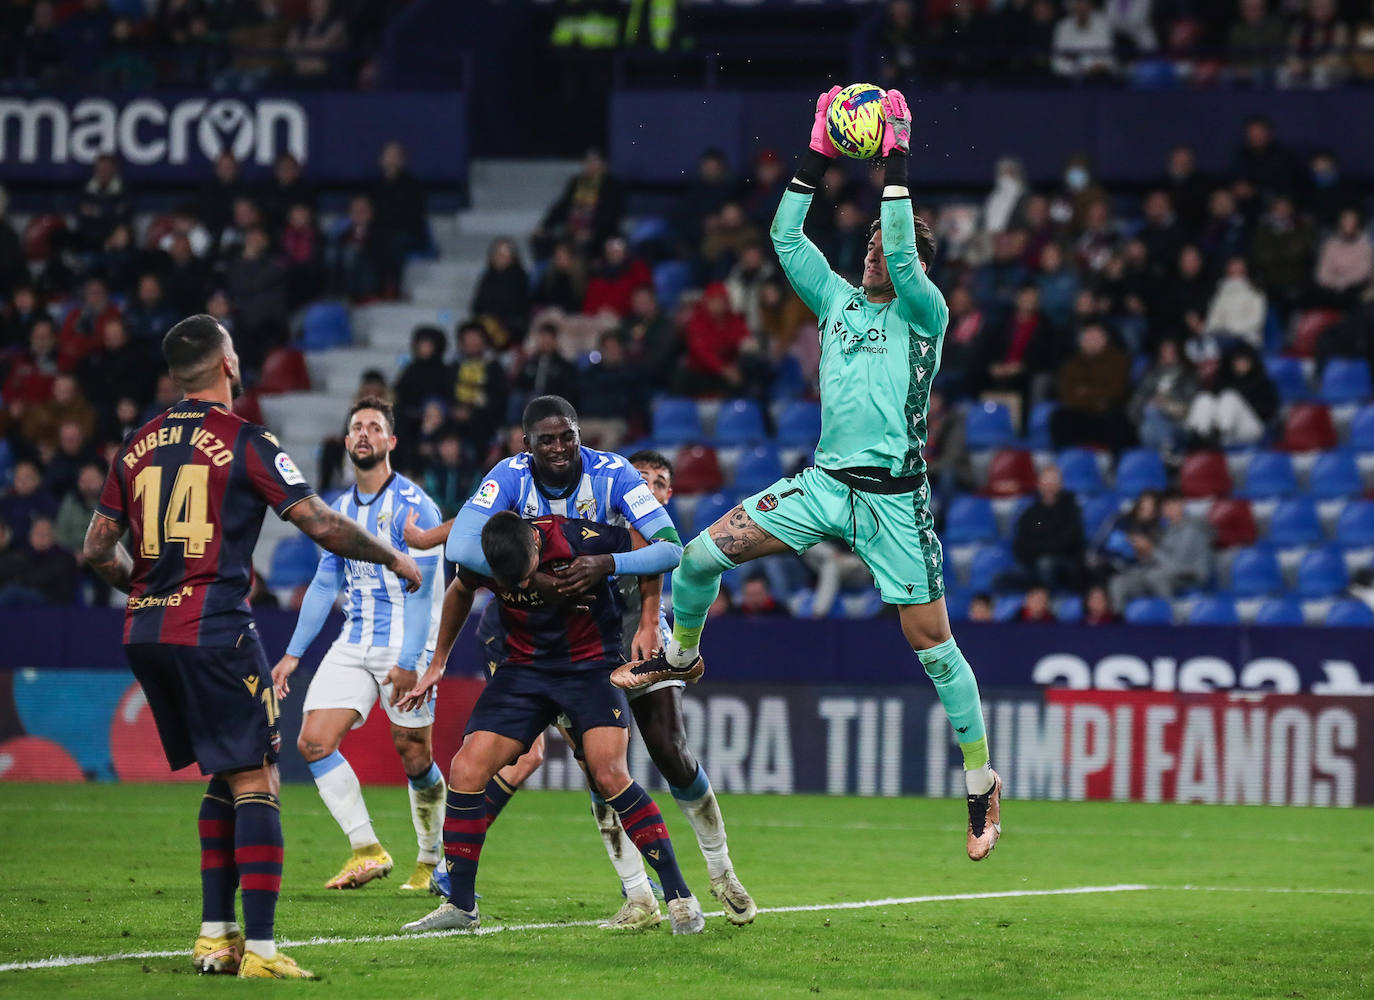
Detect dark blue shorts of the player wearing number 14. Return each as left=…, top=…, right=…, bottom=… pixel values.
left=124, top=633, right=281, bottom=775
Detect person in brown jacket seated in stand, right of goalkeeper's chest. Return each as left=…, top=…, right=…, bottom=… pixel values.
left=1050, top=323, right=1135, bottom=452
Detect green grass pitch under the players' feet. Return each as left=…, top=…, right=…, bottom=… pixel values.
left=0, top=784, right=1374, bottom=1000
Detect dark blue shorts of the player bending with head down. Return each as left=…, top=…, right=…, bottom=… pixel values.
left=463, top=663, right=629, bottom=747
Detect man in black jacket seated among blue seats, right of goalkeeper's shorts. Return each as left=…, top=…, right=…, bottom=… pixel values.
left=999, top=466, right=1084, bottom=589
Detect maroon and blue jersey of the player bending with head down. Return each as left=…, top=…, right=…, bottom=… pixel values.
left=459, top=514, right=632, bottom=670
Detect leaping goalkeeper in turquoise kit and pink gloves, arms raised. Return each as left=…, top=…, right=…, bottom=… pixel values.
left=611, top=87, right=1002, bottom=861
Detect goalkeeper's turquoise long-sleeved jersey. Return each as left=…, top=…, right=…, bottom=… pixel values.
left=772, top=188, right=949, bottom=477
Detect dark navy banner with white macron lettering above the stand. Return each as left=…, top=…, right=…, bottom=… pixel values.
left=0, top=91, right=469, bottom=184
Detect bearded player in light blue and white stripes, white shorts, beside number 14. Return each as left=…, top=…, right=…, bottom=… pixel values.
left=272, top=397, right=444, bottom=889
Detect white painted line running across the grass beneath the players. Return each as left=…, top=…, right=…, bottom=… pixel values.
left=0, top=885, right=1154, bottom=973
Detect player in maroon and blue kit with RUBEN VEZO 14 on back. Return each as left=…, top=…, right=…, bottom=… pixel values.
left=82, top=315, right=420, bottom=979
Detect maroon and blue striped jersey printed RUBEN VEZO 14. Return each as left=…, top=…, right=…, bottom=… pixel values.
left=96, top=400, right=315, bottom=647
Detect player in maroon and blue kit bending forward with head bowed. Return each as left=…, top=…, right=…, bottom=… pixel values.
left=403, top=511, right=705, bottom=934
